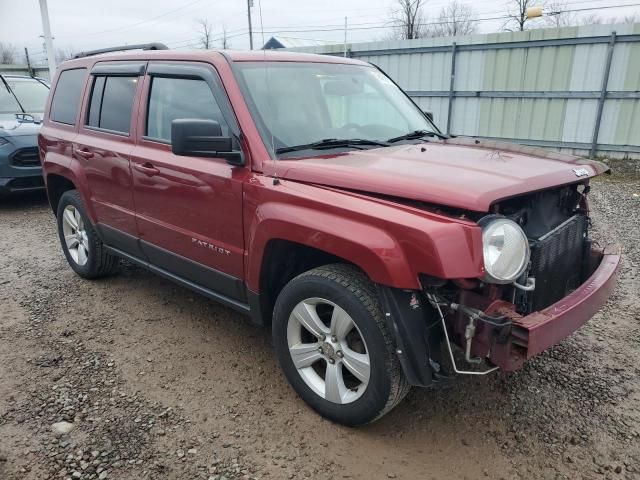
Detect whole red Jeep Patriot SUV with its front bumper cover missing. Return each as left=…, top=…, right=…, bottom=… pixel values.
left=39, top=44, right=620, bottom=425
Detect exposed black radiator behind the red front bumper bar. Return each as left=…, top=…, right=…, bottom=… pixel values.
left=527, top=215, right=587, bottom=312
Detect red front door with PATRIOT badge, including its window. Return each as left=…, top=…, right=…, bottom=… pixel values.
left=131, top=62, right=249, bottom=301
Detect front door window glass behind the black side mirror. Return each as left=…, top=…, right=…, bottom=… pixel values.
left=146, top=77, right=229, bottom=141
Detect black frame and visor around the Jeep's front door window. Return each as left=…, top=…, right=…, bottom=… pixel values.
left=140, top=60, right=241, bottom=146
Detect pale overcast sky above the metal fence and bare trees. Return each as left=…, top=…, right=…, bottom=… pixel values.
left=0, top=0, right=640, bottom=62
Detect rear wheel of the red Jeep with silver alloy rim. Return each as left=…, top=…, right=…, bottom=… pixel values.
left=57, top=190, right=119, bottom=279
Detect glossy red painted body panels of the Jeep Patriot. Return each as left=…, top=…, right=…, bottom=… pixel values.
left=39, top=50, right=619, bottom=370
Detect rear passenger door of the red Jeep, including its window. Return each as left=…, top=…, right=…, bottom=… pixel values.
left=74, top=62, right=146, bottom=256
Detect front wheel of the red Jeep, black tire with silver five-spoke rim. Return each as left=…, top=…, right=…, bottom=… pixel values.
left=272, top=264, right=410, bottom=426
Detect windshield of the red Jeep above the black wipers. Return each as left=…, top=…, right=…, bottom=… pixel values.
left=237, top=62, right=437, bottom=158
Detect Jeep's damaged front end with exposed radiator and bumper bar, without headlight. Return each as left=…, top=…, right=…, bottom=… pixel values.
left=382, top=182, right=620, bottom=385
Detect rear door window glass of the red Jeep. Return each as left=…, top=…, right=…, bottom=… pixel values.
left=87, top=76, right=138, bottom=134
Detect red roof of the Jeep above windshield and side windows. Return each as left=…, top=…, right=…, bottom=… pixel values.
left=62, top=50, right=367, bottom=69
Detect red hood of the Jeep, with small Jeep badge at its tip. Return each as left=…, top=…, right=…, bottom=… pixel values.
left=264, top=137, right=609, bottom=212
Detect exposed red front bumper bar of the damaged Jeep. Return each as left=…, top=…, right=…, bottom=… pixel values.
left=448, top=246, right=620, bottom=371
